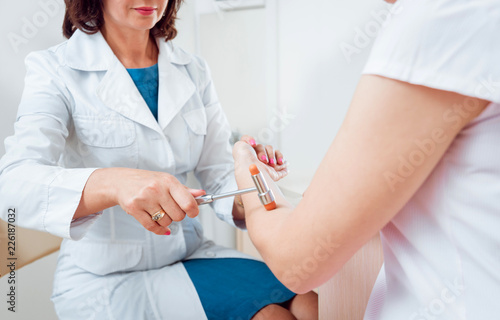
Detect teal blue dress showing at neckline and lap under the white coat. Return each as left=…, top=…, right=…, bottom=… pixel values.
left=127, top=64, right=295, bottom=320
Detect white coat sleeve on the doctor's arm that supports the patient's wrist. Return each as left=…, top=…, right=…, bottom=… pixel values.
left=194, top=61, right=246, bottom=229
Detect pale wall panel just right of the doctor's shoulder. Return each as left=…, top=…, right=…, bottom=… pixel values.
left=199, top=9, right=267, bottom=136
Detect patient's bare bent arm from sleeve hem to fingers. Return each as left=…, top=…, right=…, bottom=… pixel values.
left=233, top=75, right=488, bottom=293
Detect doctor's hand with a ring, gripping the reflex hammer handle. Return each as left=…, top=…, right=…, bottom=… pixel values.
left=114, top=168, right=205, bottom=235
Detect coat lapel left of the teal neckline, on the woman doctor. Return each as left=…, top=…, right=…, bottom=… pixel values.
left=96, top=58, right=163, bottom=134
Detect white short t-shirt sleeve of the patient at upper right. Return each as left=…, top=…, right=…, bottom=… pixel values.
left=363, top=0, right=500, bottom=103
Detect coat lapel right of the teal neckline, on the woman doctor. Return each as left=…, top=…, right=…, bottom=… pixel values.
left=158, top=38, right=196, bottom=130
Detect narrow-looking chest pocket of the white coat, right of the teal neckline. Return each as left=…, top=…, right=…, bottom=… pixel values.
left=182, top=108, right=207, bottom=169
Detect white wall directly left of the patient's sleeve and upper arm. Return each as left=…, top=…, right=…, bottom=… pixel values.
left=278, top=0, right=386, bottom=184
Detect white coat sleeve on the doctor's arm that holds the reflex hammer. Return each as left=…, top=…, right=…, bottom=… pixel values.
left=0, top=51, right=102, bottom=240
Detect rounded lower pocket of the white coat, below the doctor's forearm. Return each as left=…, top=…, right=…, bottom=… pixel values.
left=71, top=242, right=142, bottom=276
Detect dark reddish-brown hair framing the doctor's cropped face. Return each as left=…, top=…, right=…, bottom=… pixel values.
left=63, top=0, right=183, bottom=40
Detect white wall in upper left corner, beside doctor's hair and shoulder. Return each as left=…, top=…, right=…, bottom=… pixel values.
left=0, top=0, right=64, bottom=155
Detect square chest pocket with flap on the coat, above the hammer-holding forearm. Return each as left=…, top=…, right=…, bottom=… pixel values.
left=73, top=115, right=138, bottom=168
